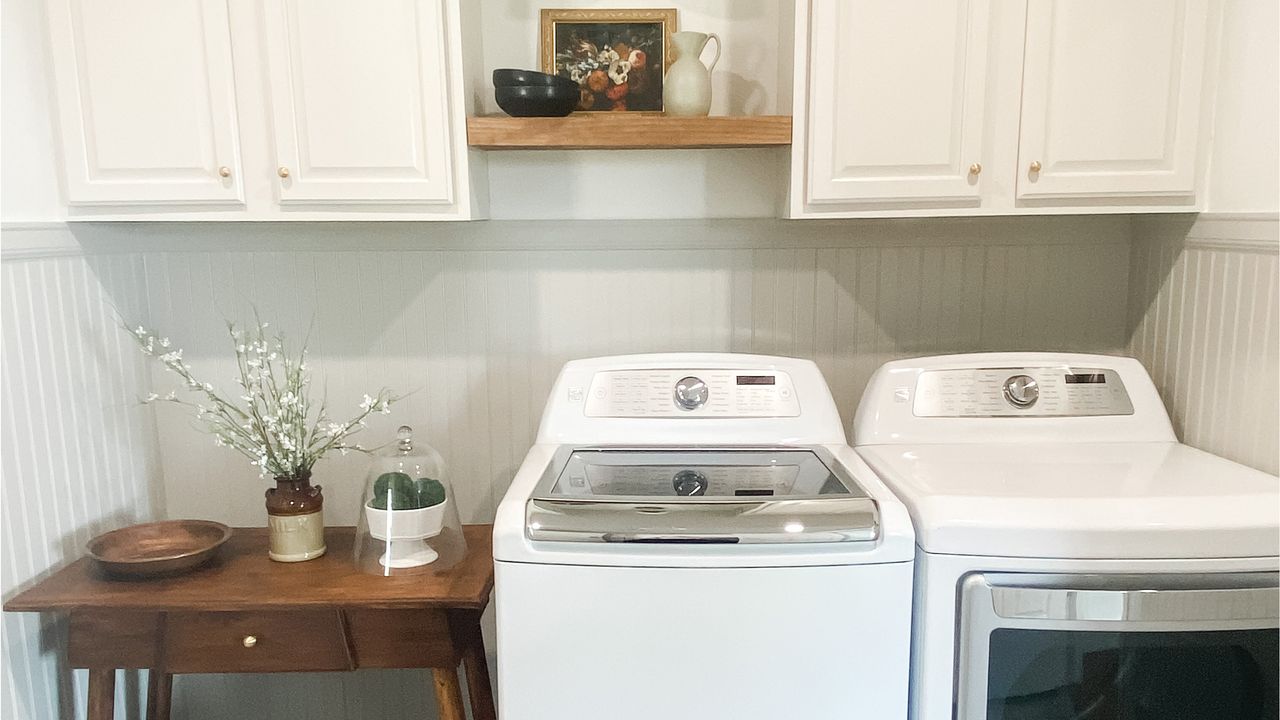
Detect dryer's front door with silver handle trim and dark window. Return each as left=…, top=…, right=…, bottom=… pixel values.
left=956, top=573, right=1280, bottom=720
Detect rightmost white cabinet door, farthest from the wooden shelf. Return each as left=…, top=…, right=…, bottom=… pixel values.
left=1018, top=0, right=1208, bottom=199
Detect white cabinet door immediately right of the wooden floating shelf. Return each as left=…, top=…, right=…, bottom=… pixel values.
left=806, top=0, right=989, bottom=204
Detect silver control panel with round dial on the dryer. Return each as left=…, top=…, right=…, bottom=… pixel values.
left=911, top=366, right=1133, bottom=418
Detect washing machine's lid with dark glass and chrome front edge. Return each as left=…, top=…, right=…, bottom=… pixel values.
left=525, top=447, right=879, bottom=543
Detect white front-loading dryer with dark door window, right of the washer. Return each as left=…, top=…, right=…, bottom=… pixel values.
left=852, top=354, right=1280, bottom=720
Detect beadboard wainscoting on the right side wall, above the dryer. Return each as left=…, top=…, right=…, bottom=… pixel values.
left=1129, top=215, right=1280, bottom=474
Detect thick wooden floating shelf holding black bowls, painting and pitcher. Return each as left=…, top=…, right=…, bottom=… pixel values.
left=467, top=113, right=791, bottom=150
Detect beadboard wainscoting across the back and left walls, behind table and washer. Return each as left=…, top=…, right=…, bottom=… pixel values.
left=4, top=217, right=1130, bottom=720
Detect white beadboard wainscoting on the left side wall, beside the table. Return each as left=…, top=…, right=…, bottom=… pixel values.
left=0, top=255, right=164, bottom=720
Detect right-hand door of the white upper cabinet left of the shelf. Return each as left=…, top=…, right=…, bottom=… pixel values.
left=265, top=0, right=452, bottom=205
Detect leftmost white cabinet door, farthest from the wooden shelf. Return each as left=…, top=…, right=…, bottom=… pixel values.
left=47, top=0, right=243, bottom=206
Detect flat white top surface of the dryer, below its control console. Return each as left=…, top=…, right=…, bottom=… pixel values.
left=856, top=442, right=1280, bottom=560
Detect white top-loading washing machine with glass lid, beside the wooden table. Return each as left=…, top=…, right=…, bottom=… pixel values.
left=494, top=354, right=914, bottom=720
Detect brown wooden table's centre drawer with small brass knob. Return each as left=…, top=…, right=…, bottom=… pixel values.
left=164, top=610, right=353, bottom=673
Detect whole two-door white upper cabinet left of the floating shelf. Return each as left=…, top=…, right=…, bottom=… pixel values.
left=49, top=0, right=484, bottom=220
